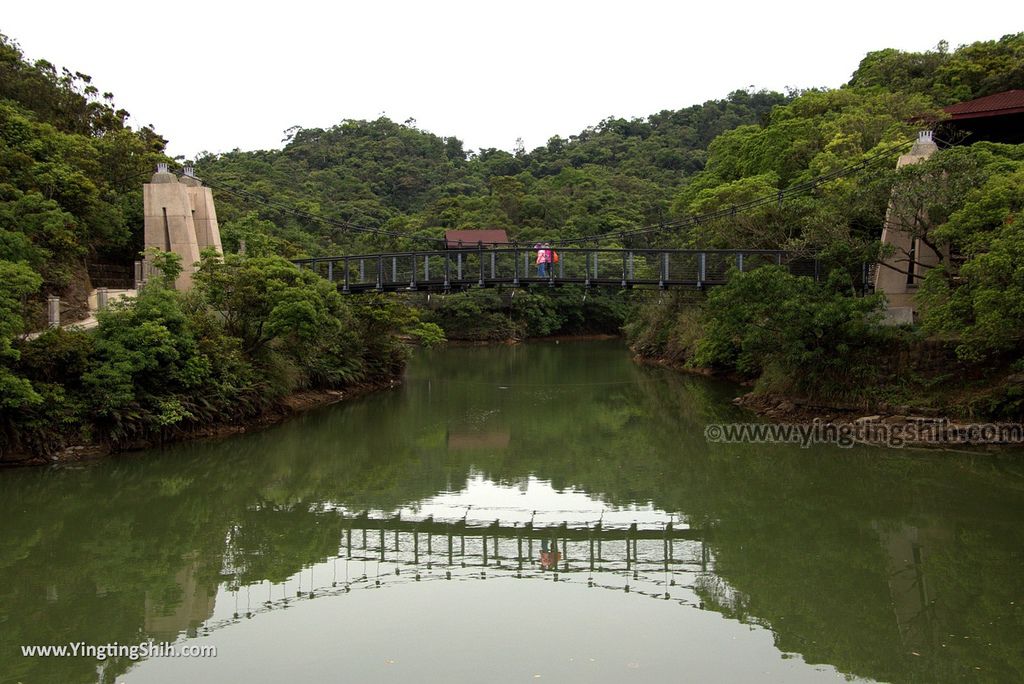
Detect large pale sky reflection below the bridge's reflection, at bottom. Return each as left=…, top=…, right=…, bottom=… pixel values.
left=125, top=568, right=864, bottom=684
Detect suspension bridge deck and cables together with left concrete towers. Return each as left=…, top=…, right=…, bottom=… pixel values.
left=130, top=140, right=910, bottom=296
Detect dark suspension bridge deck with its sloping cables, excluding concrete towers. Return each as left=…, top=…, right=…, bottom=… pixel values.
left=262, top=137, right=913, bottom=294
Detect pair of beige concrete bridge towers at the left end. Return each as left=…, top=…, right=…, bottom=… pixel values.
left=142, top=164, right=223, bottom=291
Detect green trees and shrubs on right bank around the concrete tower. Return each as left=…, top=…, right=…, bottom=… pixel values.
left=627, top=135, right=1024, bottom=419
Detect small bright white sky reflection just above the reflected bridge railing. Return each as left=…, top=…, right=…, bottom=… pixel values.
left=338, top=473, right=685, bottom=528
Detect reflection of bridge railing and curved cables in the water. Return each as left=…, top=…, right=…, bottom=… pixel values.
left=201, top=513, right=714, bottom=634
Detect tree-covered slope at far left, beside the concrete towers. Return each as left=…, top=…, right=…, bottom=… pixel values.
left=0, top=34, right=165, bottom=284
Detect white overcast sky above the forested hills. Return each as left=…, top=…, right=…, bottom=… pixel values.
left=0, top=0, right=1024, bottom=158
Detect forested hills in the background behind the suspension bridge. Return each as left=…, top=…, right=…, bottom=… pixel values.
left=197, top=91, right=788, bottom=255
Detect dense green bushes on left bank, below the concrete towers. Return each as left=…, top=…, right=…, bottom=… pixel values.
left=0, top=245, right=417, bottom=456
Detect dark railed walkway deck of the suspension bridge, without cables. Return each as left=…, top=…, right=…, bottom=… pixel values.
left=293, top=245, right=824, bottom=294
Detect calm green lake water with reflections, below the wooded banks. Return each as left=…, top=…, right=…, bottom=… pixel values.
left=0, top=341, right=1024, bottom=683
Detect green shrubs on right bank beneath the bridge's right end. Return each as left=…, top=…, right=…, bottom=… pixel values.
left=627, top=265, right=889, bottom=392
